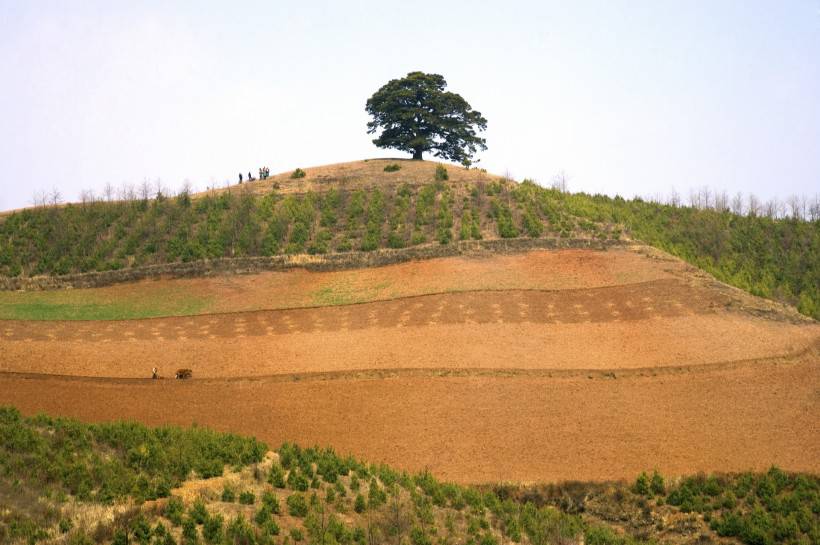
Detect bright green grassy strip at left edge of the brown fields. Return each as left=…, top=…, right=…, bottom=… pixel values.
left=0, top=288, right=213, bottom=320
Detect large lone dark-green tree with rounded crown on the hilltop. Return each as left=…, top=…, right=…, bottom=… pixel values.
left=365, top=72, right=487, bottom=164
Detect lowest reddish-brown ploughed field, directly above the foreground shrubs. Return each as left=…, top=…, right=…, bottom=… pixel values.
left=0, top=359, right=820, bottom=482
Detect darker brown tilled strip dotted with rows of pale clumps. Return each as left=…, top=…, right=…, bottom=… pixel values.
left=0, top=280, right=728, bottom=341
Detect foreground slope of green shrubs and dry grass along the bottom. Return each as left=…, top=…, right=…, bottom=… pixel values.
left=0, top=408, right=820, bottom=545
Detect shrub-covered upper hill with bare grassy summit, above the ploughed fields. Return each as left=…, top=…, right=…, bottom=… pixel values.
left=0, top=160, right=820, bottom=318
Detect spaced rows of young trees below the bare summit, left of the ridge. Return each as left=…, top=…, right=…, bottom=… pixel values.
left=0, top=180, right=608, bottom=276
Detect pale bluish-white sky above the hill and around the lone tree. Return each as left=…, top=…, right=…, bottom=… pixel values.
left=0, top=0, right=820, bottom=210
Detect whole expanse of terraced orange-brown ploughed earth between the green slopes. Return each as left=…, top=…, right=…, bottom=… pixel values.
left=0, top=250, right=820, bottom=482
